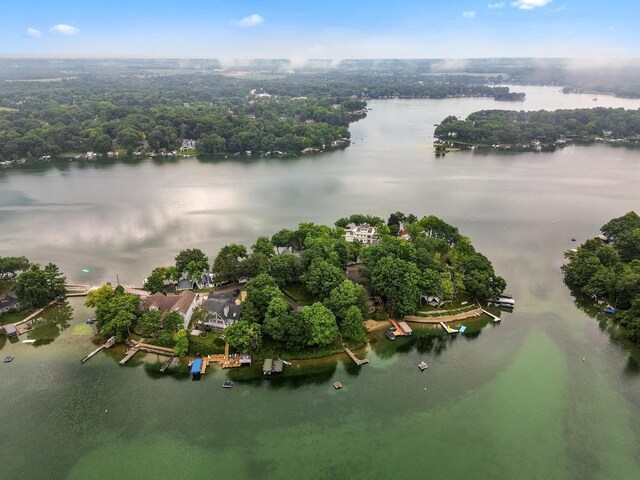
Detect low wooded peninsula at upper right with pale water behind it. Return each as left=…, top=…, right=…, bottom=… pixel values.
left=435, top=108, right=640, bottom=148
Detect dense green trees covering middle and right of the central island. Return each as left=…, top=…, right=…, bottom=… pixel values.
left=135, top=212, right=506, bottom=352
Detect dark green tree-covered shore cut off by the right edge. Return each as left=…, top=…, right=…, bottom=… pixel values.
left=563, top=212, right=640, bottom=343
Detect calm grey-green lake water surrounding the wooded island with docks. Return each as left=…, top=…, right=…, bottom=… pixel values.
left=0, top=87, right=640, bottom=479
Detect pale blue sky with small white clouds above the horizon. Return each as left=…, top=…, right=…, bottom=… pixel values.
left=0, top=0, right=640, bottom=59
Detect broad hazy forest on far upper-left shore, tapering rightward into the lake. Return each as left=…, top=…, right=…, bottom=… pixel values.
left=0, top=60, right=523, bottom=161
